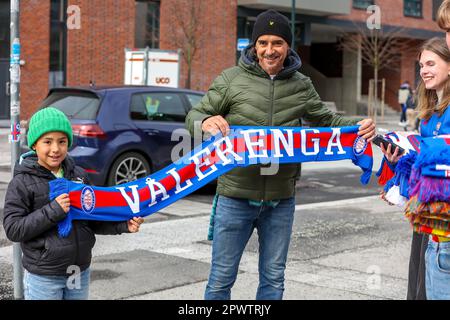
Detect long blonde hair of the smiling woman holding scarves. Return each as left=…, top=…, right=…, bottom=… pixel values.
left=417, top=37, right=450, bottom=120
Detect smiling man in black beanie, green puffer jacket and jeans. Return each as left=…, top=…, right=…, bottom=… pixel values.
left=186, top=10, right=375, bottom=299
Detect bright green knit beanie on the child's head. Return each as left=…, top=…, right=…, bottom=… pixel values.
left=27, top=107, right=73, bottom=148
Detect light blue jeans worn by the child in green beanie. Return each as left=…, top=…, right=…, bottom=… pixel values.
left=23, top=268, right=90, bottom=300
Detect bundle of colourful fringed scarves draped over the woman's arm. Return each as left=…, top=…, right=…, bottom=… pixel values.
left=376, top=135, right=450, bottom=241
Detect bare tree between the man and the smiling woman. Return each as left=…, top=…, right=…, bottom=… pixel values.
left=339, top=23, right=415, bottom=118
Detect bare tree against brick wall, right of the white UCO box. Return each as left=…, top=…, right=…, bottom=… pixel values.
left=172, top=0, right=206, bottom=89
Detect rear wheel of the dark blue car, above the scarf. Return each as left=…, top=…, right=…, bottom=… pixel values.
left=108, top=152, right=150, bottom=186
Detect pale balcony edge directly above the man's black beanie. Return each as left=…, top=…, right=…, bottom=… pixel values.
left=238, top=0, right=352, bottom=16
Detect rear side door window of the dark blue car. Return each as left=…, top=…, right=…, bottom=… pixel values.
left=130, top=92, right=186, bottom=122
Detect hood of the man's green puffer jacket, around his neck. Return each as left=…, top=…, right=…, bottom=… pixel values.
left=238, top=44, right=302, bottom=79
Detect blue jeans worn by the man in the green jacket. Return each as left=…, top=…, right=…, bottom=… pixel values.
left=205, top=196, right=295, bottom=300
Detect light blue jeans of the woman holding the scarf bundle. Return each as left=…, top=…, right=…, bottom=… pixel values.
left=425, top=238, right=450, bottom=300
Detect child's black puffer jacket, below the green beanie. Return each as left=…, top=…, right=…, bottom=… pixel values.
left=3, top=154, right=128, bottom=275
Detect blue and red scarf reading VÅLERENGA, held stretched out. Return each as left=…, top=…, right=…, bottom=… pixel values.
left=49, top=126, right=373, bottom=236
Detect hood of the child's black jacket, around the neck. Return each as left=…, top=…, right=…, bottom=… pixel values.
left=14, top=151, right=75, bottom=179
